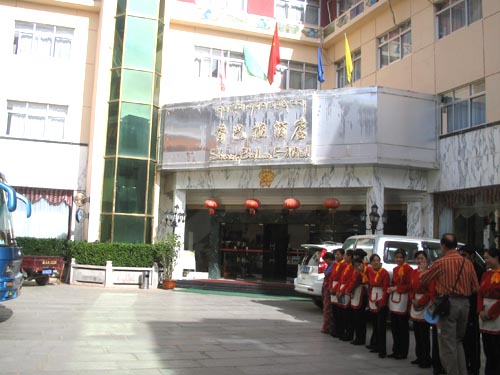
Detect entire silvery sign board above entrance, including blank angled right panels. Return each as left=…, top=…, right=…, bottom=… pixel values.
left=160, top=87, right=438, bottom=170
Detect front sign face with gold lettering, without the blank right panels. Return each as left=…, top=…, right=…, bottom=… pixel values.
left=163, top=94, right=311, bottom=167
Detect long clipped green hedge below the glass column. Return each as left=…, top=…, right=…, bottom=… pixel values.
left=17, top=237, right=159, bottom=267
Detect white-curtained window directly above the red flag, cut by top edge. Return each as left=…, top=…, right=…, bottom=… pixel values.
left=274, top=0, right=319, bottom=26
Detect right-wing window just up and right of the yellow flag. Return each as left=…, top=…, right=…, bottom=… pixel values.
left=378, top=21, right=411, bottom=68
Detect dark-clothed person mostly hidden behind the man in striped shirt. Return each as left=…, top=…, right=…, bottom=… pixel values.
left=459, top=245, right=485, bottom=375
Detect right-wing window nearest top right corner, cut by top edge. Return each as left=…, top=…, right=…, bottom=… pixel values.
left=435, top=0, right=483, bottom=39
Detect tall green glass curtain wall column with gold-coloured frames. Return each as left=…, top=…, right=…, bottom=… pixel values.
left=100, top=0, right=165, bottom=243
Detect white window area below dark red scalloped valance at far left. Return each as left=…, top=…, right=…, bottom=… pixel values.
left=12, top=198, right=70, bottom=239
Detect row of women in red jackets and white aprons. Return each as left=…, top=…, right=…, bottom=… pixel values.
left=321, top=239, right=500, bottom=375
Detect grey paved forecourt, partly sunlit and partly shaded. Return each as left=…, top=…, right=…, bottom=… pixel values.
left=0, top=284, right=438, bottom=375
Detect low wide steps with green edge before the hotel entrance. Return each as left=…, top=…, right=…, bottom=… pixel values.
left=176, top=279, right=304, bottom=297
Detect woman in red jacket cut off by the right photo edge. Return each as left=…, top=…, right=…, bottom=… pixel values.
left=477, top=249, right=500, bottom=375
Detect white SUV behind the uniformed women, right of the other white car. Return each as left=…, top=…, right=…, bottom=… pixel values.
left=343, top=234, right=443, bottom=276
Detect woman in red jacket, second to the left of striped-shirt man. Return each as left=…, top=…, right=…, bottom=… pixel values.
left=387, top=249, right=413, bottom=359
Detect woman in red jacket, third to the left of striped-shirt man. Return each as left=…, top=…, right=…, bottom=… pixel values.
left=367, top=254, right=390, bottom=358
